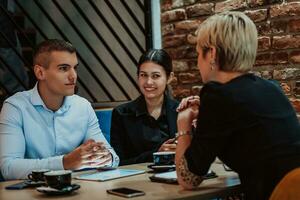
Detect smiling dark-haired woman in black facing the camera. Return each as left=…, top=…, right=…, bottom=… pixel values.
left=110, top=49, right=178, bottom=165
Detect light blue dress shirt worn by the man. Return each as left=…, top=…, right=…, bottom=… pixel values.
left=0, top=84, right=119, bottom=180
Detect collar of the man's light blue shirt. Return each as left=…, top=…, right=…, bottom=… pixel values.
left=30, top=83, right=72, bottom=114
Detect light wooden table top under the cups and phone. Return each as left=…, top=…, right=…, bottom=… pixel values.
left=0, top=163, right=240, bottom=200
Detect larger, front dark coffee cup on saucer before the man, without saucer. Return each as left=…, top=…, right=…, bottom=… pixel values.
left=44, top=170, right=72, bottom=190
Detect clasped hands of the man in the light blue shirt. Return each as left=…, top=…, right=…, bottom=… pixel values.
left=63, top=140, right=112, bottom=170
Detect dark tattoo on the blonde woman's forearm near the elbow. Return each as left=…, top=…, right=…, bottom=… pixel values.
left=178, top=156, right=202, bottom=187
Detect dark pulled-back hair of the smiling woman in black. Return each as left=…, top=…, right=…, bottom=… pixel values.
left=137, top=49, right=172, bottom=77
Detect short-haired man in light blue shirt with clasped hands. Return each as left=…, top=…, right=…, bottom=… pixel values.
left=0, top=39, right=119, bottom=180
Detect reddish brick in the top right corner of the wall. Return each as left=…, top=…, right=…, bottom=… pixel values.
left=270, top=2, right=300, bottom=18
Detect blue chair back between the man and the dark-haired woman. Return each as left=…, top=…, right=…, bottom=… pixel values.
left=95, top=108, right=112, bottom=143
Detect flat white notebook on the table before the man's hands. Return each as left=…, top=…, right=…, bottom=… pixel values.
left=75, top=169, right=145, bottom=181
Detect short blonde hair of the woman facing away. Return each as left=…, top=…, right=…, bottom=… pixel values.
left=197, top=12, right=257, bottom=72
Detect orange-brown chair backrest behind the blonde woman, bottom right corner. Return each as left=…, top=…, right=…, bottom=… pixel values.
left=269, top=167, right=300, bottom=200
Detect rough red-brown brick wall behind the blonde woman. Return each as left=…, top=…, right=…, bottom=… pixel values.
left=161, top=0, right=300, bottom=111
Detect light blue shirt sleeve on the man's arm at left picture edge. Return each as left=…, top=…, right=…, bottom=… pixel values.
left=0, top=102, right=64, bottom=180
